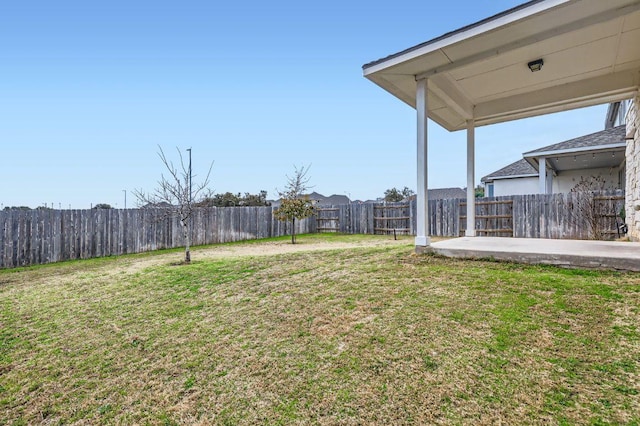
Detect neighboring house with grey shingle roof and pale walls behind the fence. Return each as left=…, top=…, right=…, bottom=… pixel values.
left=481, top=125, right=627, bottom=197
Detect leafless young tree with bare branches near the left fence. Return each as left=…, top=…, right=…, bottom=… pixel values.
left=134, top=146, right=213, bottom=263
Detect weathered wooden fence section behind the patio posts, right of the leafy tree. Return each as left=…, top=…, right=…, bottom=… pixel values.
left=334, top=190, right=624, bottom=239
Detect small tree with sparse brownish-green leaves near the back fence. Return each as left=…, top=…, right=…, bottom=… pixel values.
left=275, top=165, right=315, bottom=244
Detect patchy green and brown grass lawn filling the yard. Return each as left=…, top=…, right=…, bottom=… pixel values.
left=0, top=236, right=640, bottom=425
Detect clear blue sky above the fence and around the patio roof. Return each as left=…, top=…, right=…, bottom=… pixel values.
left=0, top=0, right=606, bottom=208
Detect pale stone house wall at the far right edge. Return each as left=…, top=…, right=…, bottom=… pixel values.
left=625, top=95, right=640, bottom=241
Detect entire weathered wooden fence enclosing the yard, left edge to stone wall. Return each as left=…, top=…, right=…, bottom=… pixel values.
left=0, top=191, right=624, bottom=268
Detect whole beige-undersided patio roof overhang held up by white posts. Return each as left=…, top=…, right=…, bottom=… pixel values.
left=363, top=0, right=640, bottom=131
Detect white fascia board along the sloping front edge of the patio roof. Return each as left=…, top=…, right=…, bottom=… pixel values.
left=363, top=0, right=573, bottom=76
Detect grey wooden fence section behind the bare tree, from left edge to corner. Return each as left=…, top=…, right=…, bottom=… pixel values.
left=0, top=207, right=316, bottom=268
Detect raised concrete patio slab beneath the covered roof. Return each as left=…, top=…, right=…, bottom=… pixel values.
left=431, top=237, right=640, bottom=272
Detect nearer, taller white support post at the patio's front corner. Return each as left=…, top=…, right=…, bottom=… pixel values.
left=415, top=79, right=431, bottom=250
